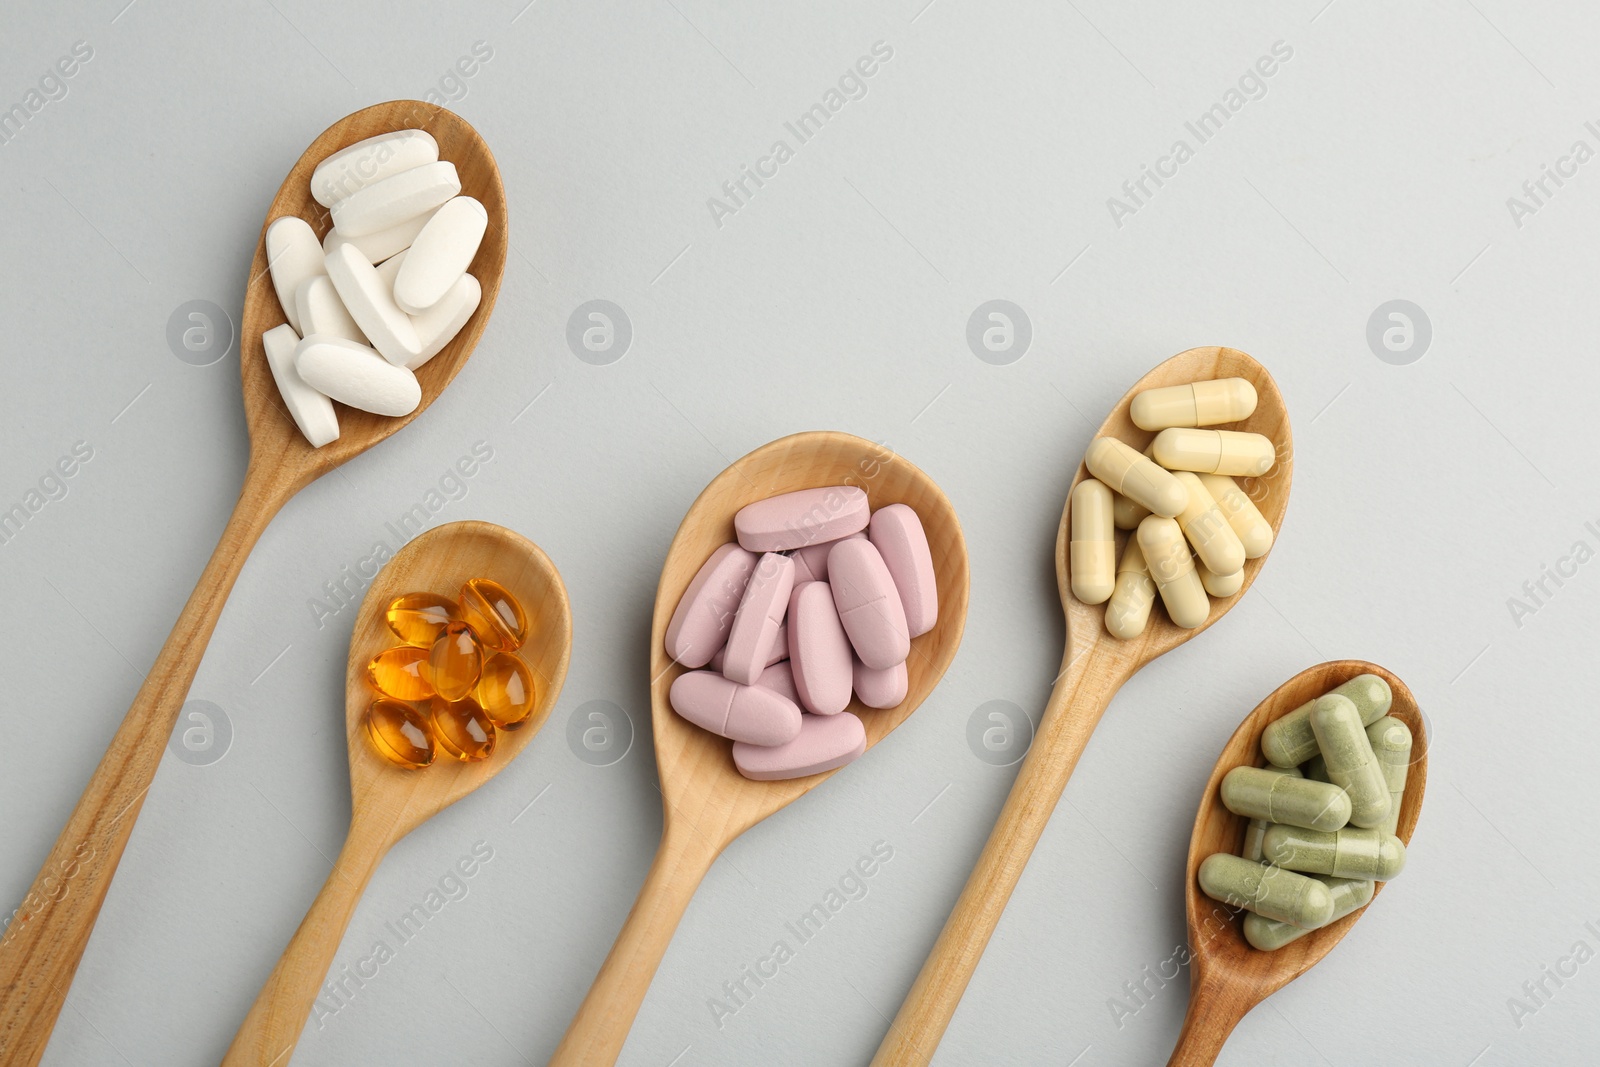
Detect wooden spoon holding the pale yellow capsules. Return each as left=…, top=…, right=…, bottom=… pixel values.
left=872, top=349, right=1294, bottom=1065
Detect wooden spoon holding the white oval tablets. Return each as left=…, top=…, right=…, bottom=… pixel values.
left=0, top=101, right=507, bottom=1064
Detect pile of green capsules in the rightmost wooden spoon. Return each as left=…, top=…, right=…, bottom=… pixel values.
left=1200, top=675, right=1411, bottom=952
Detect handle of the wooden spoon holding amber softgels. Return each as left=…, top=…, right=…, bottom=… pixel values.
left=222, top=821, right=390, bottom=1067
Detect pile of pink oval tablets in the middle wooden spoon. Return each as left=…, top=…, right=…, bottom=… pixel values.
left=666, top=485, right=939, bottom=781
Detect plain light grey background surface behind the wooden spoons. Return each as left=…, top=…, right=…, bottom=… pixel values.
left=0, top=0, right=1600, bottom=1067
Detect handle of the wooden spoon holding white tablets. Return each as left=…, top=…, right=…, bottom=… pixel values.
left=0, top=466, right=293, bottom=1067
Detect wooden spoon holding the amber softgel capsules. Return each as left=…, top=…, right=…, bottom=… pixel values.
left=222, top=522, right=573, bottom=1067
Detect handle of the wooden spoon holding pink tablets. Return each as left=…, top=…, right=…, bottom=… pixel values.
left=550, top=809, right=725, bottom=1067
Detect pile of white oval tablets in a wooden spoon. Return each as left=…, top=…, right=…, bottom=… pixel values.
left=261, top=130, right=490, bottom=448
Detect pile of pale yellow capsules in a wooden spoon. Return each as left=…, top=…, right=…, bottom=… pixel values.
left=1069, top=378, right=1277, bottom=640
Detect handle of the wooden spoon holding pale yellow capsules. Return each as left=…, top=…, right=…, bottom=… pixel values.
left=872, top=643, right=1126, bottom=1067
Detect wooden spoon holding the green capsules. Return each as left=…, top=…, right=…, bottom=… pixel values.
left=1168, top=659, right=1427, bottom=1067
